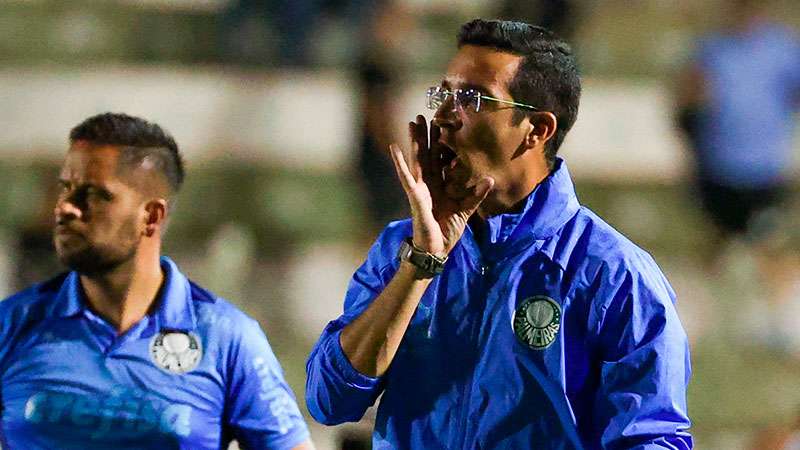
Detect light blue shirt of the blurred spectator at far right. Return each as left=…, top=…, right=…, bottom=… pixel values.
left=697, top=24, right=800, bottom=189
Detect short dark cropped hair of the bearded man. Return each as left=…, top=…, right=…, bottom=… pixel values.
left=69, top=113, right=184, bottom=194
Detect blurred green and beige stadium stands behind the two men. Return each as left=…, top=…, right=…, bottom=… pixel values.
left=0, top=0, right=800, bottom=449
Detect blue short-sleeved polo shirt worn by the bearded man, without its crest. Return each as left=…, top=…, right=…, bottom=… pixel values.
left=0, top=257, right=308, bottom=450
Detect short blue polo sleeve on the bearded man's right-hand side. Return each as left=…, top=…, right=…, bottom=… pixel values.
left=226, top=318, right=309, bottom=450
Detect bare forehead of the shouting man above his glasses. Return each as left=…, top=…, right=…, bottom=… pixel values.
left=445, top=45, right=522, bottom=93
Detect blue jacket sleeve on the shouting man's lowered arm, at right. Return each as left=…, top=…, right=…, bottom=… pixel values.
left=593, top=255, right=693, bottom=450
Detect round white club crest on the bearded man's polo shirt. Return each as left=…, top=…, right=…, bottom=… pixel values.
left=150, top=331, right=203, bottom=374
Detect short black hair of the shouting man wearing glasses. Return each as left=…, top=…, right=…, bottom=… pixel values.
left=458, top=19, right=581, bottom=167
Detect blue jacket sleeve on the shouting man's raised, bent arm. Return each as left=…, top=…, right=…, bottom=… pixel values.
left=306, top=225, right=410, bottom=425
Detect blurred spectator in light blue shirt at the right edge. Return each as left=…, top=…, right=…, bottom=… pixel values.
left=677, top=0, right=800, bottom=355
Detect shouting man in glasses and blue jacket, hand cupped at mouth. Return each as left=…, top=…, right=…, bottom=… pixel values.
left=306, top=20, right=692, bottom=449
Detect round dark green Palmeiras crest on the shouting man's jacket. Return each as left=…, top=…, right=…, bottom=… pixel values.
left=512, top=295, right=561, bottom=350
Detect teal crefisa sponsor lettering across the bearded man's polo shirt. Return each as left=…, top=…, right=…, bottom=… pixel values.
left=25, top=388, right=192, bottom=439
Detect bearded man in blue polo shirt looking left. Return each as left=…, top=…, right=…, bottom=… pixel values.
left=0, top=114, right=312, bottom=450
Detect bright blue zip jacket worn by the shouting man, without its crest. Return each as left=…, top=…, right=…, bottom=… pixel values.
left=306, top=160, right=692, bottom=450
